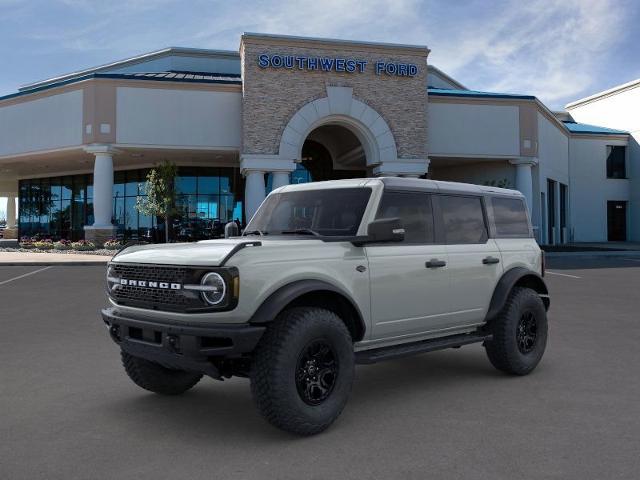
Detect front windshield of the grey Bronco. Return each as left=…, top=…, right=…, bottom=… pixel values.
left=244, top=187, right=371, bottom=236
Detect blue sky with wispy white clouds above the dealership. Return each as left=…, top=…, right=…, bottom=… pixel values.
left=0, top=0, right=640, bottom=218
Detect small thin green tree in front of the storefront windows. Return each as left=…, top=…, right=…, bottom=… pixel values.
left=136, top=160, right=178, bottom=243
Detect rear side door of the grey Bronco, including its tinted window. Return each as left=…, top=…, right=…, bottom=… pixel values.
left=438, top=195, right=503, bottom=328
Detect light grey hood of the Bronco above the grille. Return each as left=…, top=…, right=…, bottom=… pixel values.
left=113, top=237, right=261, bottom=267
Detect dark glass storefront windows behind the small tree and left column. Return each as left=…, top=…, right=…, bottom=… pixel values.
left=19, top=167, right=244, bottom=241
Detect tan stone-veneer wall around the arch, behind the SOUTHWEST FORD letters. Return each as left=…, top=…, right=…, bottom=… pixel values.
left=240, top=36, right=428, bottom=158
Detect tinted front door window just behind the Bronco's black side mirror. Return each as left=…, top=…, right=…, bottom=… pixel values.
left=376, top=191, right=434, bottom=243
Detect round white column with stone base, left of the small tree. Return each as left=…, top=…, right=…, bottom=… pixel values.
left=84, top=145, right=116, bottom=245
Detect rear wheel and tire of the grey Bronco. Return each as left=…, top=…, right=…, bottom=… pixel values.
left=485, top=287, right=547, bottom=375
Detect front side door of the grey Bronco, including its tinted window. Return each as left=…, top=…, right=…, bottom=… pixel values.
left=366, top=191, right=450, bottom=339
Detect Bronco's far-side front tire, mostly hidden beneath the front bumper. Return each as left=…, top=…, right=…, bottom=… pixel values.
left=120, top=351, right=202, bottom=395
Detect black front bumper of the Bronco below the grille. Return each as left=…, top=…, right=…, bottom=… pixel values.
left=102, top=307, right=265, bottom=378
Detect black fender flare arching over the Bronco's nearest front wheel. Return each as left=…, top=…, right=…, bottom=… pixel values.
left=249, top=280, right=366, bottom=338
